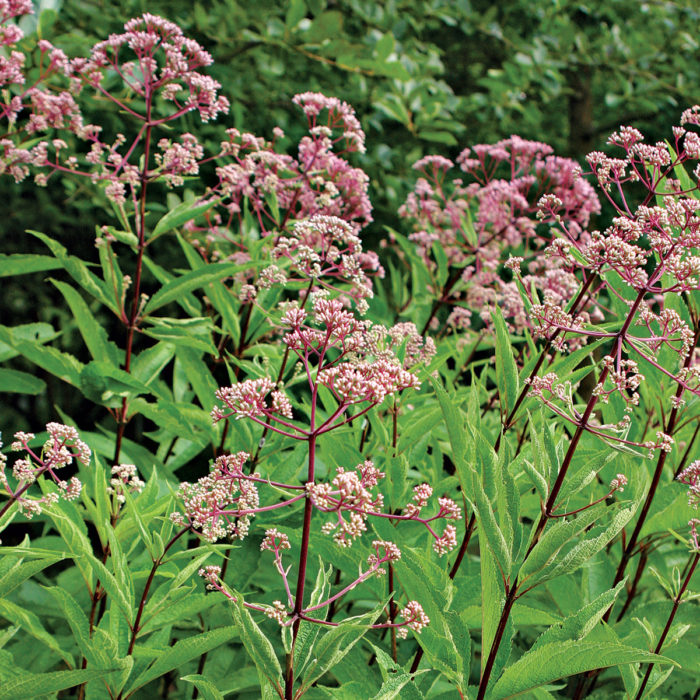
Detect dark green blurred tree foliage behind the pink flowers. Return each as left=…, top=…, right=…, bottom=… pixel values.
left=0, top=0, right=700, bottom=430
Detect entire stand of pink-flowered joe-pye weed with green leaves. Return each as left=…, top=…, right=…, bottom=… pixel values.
left=0, top=0, right=700, bottom=700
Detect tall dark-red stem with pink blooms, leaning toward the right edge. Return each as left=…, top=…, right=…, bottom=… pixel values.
left=477, top=108, right=700, bottom=700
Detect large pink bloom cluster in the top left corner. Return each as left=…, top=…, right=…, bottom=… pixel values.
left=0, top=10, right=229, bottom=204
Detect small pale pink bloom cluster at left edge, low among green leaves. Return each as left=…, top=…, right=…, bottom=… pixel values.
left=0, top=423, right=91, bottom=518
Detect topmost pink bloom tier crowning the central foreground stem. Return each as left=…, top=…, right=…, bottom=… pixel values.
left=211, top=293, right=420, bottom=440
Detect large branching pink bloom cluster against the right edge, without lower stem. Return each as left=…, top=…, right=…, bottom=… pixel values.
left=530, top=107, right=700, bottom=451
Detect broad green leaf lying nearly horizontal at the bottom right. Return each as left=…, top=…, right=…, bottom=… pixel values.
left=489, top=641, right=674, bottom=700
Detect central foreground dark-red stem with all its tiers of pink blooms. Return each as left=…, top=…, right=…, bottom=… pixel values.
left=173, top=293, right=452, bottom=698
